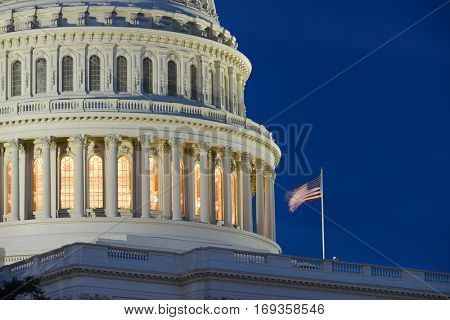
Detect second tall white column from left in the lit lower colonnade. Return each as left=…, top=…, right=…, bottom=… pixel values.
left=41, top=137, right=52, bottom=219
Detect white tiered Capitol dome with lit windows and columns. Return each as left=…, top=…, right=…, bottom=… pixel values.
left=0, top=0, right=281, bottom=265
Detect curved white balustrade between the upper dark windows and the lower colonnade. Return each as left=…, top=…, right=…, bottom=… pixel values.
left=0, top=99, right=272, bottom=140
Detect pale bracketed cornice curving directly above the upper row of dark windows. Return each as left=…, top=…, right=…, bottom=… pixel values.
left=0, top=26, right=252, bottom=82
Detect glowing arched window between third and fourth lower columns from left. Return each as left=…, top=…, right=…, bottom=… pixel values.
left=89, top=156, right=103, bottom=209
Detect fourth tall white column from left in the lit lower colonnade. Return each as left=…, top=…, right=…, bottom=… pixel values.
left=105, top=135, right=119, bottom=218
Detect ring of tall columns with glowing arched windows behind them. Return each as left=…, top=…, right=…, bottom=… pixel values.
left=0, top=135, right=275, bottom=240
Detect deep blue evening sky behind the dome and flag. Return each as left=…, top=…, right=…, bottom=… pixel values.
left=216, top=0, right=450, bottom=272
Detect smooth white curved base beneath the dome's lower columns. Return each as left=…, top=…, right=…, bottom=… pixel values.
left=0, top=218, right=281, bottom=265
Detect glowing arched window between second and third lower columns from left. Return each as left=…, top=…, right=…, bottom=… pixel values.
left=60, top=156, right=75, bottom=209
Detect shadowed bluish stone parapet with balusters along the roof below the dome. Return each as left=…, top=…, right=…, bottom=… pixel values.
left=0, top=244, right=450, bottom=296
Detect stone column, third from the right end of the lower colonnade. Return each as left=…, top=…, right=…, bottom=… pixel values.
left=241, top=153, right=253, bottom=232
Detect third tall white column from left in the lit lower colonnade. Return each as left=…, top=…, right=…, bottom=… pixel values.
left=73, top=135, right=85, bottom=218
